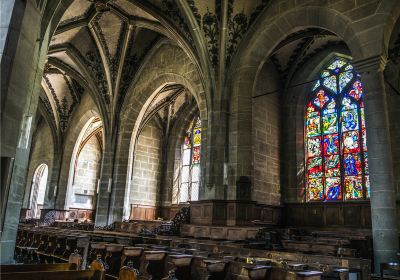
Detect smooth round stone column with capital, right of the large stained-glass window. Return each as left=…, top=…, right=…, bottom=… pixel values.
left=354, top=56, right=399, bottom=272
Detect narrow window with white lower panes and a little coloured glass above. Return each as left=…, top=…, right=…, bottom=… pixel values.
left=177, top=117, right=201, bottom=203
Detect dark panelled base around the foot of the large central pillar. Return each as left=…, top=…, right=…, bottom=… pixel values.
left=190, top=200, right=281, bottom=226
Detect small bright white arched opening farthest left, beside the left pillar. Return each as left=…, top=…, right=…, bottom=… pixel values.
left=29, top=163, right=49, bottom=219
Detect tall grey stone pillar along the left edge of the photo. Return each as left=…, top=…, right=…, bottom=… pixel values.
left=0, top=0, right=47, bottom=263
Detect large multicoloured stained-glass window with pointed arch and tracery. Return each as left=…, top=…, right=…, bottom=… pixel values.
left=304, top=58, right=370, bottom=201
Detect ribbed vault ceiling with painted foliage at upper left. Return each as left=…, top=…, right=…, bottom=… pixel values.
left=40, top=0, right=165, bottom=134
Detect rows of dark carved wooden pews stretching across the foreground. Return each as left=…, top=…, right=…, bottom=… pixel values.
left=16, top=226, right=376, bottom=280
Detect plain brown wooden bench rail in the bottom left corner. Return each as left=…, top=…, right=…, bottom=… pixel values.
left=0, top=263, right=77, bottom=272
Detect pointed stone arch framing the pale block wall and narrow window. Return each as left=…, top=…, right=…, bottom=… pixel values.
left=112, top=40, right=207, bottom=223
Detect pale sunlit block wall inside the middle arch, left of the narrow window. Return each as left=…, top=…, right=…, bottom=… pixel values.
left=130, top=120, right=162, bottom=206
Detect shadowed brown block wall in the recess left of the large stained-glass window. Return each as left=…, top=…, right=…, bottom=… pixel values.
left=251, top=60, right=281, bottom=205
